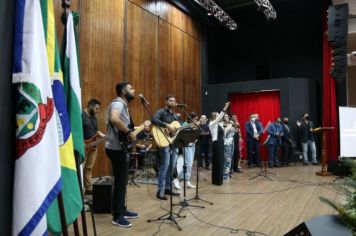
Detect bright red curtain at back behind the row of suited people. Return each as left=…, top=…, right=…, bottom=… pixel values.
left=229, top=91, right=281, bottom=160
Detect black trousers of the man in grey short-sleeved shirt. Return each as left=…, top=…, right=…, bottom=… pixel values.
left=105, top=149, right=129, bottom=220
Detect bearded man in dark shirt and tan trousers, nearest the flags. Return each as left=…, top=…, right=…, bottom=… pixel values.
left=82, top=98, right=105, bottom=195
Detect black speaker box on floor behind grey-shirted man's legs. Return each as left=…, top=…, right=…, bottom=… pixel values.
left=93, top=178, right=114, bottom=214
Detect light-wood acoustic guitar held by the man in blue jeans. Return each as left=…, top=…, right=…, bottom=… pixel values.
left=151, top=121, right=198, bottom=148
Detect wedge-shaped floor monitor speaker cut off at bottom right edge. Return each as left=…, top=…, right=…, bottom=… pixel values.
left=285, top=215, right=352, bottom=236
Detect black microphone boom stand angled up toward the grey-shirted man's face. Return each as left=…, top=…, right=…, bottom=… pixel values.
left=142, top=100, right=186, bottom=231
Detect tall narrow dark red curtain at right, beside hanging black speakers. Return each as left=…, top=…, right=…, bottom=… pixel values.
left=323, top=1, right=339, bottom=160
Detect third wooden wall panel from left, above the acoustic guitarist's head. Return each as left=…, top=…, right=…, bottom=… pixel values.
left=159, top=20, right=184, bottom=106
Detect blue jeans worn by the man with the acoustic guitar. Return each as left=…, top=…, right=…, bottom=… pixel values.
left=158, top=147, right=178, bottom=194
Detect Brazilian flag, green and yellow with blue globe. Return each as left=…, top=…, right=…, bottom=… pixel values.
left=41, top=0, right=83, bottom=234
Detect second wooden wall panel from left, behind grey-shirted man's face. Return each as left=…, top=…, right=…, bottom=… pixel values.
left=125, top=2, right=158, bottom=124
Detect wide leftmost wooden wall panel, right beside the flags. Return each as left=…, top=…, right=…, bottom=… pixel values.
left=79, top=0, right=125, bottom=176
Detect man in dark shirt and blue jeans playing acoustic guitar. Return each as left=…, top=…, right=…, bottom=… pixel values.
left=152, top=95, right=179, bottom=200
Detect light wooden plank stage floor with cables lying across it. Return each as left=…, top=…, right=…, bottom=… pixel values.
left=78, top=164, right=342, bottom=236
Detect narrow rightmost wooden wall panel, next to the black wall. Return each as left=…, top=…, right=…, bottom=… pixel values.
left=183, top=34, right=201, bottom=113
